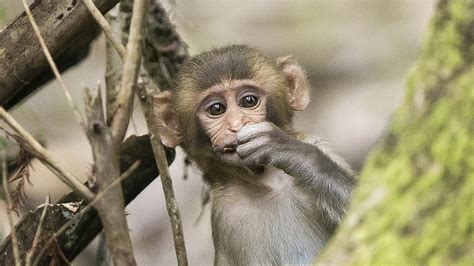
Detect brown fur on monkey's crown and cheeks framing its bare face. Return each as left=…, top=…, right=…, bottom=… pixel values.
left=172, top=45, right=292, bottom=172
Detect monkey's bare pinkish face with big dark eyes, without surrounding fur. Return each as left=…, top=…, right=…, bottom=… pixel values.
left=197, top=80, right=267, bottom=165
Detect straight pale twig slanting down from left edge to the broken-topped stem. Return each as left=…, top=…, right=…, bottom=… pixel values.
left=0, top=107, right=94, bottom=201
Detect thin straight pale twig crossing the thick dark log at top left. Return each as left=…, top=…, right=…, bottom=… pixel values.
left=21, top=0, right=85, bottom=130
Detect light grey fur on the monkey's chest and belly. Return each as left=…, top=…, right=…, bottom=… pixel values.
left=211, top=167, right=327, bottom=265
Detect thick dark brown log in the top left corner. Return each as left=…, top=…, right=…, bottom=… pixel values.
left=0, top=0, right=118, bottom=109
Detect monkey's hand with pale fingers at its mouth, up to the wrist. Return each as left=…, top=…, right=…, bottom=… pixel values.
left=236, top=122, right=314, bottom=175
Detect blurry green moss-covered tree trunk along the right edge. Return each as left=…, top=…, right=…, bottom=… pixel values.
left=320, top=0, right=474, bottom=265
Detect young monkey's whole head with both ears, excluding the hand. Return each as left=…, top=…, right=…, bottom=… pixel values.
left=154, top=45, right=309, bottom=171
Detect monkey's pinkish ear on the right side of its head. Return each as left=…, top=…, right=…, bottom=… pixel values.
left=277, top=55, right=309, bottom=111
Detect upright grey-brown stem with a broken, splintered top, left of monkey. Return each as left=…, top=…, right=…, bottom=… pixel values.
left=85, top=89, right=136, bottom=265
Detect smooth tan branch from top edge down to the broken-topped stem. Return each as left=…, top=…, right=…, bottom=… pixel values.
left=112, top=0, right=149, bottom=143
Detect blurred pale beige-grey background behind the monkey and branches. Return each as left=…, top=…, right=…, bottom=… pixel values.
left=0, top=0, right=435, bottom=265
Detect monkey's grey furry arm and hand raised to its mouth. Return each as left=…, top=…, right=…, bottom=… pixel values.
left=237, top=122, right=355, bottom=225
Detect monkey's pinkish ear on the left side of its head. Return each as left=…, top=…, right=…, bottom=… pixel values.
left=153, top=91, right=182, bottom=148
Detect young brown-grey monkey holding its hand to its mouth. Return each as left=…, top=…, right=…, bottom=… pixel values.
left=155, top=45, right=355, bottom=265
